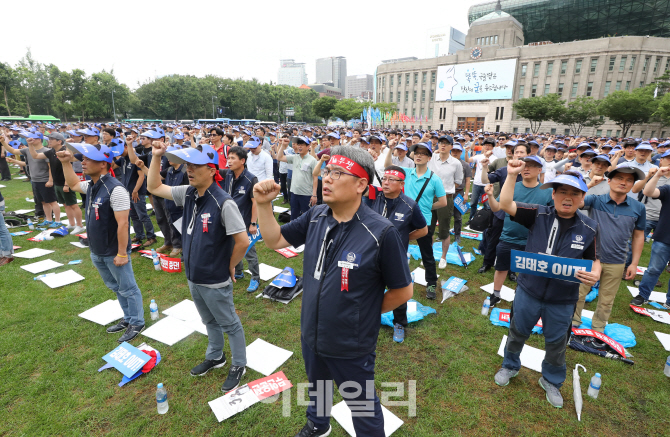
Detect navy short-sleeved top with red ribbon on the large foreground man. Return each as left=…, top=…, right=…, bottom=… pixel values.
left=281, top=203, right=412, bottom=359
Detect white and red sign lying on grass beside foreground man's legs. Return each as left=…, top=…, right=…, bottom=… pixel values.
left=209, top=372, right=293, bottom=422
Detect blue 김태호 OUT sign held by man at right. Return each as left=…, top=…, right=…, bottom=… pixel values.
left=511, top=250, right=593, bottom=283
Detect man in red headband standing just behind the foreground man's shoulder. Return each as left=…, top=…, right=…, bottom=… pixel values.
left=369, top=165, right=428, bottom=343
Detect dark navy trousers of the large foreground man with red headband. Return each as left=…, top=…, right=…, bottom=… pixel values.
left=301, top=337, right=385, bottom=437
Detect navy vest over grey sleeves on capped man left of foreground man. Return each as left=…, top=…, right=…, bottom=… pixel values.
left=181, top=182, right=234, bottom=284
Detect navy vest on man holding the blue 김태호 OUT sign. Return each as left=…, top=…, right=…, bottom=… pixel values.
left=512, top=205, right=598, bottom=304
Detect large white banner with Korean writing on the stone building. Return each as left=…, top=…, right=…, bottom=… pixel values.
left=435, top=59, right=516, bottom=102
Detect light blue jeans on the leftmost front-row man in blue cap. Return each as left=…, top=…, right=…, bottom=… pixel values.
left=91, top=252, right=144, bottom=326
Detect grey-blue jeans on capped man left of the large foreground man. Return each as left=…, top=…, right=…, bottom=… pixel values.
left=188, top=281, right=247, bottom=366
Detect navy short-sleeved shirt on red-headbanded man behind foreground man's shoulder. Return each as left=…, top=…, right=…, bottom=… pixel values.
left=370, top=185, right=427, bottom=248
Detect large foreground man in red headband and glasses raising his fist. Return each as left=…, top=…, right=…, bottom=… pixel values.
left=254, top=146, right=412, bottom=437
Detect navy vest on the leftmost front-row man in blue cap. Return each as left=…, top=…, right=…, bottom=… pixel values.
left=86, top=174, right=130, bottom=256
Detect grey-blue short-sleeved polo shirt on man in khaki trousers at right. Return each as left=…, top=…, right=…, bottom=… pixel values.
left=584, top=193, right=648, bottom=264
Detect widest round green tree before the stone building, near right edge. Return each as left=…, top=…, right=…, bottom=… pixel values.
left=599, top=87, right=657, bottom=137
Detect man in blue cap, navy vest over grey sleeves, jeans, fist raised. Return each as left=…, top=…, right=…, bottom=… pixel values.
left=147, top=141, right=249, bottom=393
